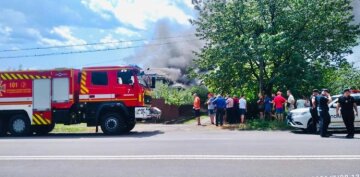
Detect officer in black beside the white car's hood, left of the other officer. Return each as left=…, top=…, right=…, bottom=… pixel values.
left=316, top=89, right=332, bottom=138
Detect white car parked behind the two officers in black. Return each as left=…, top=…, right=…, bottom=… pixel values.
left=287, top=93, right=360, bottom=132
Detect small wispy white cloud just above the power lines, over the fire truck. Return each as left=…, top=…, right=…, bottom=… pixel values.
left=38, top=26, right=86, bottom=50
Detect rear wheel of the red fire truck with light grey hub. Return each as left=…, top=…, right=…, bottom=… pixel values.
left=8, top=114, right=31, bottom=136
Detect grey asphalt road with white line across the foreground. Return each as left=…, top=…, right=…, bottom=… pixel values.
left=0, top=125, right=360, bottom=177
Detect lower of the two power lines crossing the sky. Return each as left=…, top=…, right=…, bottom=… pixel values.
left=0, top=39, right=198, bottom=60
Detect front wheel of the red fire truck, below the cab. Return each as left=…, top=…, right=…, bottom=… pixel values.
left=101, top=113, right=126, bottom=135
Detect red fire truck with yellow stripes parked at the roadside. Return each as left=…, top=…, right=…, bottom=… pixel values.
left=0, top=66, right=155, bottom=136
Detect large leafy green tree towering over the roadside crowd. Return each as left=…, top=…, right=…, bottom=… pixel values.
left=192, top=0, right=360, bottom=98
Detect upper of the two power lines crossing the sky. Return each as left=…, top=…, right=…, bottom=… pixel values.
left=0, top=34, right=194, bottom=53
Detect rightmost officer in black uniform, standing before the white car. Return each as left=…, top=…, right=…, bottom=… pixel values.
left=336, top=89, right=358, bottom=138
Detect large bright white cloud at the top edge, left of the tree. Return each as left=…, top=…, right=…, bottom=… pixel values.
left=81, top=0, right=191, bottom=29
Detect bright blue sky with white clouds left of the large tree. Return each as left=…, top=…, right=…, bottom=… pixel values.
left=0, top=0, right=360, bottom=70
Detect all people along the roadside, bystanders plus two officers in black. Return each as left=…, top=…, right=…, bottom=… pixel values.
left=194, top=89, right=358, bottom=138
